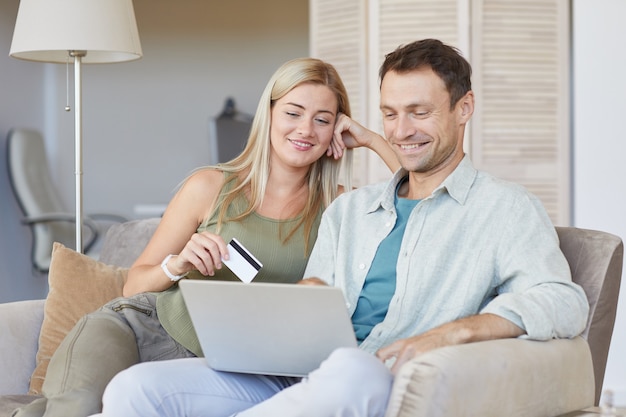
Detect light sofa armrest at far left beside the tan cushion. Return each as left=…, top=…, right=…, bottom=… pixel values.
left=0, top=300, right=44, bottom=395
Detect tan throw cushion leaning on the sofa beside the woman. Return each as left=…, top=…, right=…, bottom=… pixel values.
left=29, top=242, right=128, bottom=394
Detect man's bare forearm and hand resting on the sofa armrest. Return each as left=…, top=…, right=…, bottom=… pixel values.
left=376, top=313, right=525, bottom=374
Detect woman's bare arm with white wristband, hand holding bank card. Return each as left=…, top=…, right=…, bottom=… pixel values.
left=123, top=169, right=228, bottom=297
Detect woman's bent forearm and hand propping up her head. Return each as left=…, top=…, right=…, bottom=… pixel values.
left=328, top=114, right=400, bottom=172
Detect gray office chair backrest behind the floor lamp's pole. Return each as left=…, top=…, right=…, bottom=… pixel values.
left=6, top=129, right=76, bottom=271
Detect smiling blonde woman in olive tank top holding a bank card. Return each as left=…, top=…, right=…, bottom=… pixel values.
left=14, top=58, right=399, bottom=417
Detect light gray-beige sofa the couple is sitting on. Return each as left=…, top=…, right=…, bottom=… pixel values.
left=0, top=219, right=623, bottom=417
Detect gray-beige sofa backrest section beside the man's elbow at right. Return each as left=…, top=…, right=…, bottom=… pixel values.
left=556, top=227, right=624, bottom=405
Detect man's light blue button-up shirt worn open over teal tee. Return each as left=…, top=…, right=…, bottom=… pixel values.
left=304, top=156, right=589, bottom=352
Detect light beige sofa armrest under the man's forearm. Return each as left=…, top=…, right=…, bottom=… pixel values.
left=386, top=337, right=595, bottom=417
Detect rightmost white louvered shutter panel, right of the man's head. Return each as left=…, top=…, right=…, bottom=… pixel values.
left=471, top=0, right=570, bottom=225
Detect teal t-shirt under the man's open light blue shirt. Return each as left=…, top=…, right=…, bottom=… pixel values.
left=352, top=177, right=420, bottom=343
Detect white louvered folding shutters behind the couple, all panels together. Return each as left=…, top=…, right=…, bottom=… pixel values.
left=310, top=0, right=570, bottom=225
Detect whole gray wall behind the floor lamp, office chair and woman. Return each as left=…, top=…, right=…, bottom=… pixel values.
left=0, top=0, right=308, bottom=302
